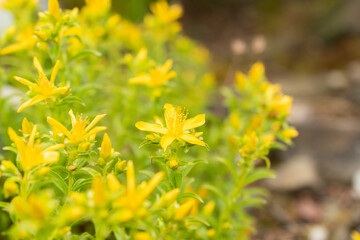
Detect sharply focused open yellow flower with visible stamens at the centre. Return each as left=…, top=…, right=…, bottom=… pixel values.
left=135, top=104, right=205, bottom=151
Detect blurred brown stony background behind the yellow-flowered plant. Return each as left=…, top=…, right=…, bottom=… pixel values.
left=0, top=0, right=360, bottom=240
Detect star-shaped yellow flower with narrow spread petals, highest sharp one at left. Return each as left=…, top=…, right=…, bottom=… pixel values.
left=14, top=57, right=70, bottom=112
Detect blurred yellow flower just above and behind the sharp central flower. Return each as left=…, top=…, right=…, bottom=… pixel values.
left=129, top=60, right=176, bottom=88
